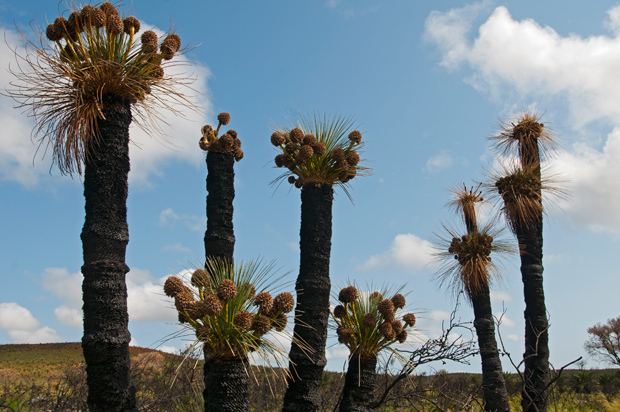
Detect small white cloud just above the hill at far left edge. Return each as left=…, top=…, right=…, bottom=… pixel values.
left=0, top=302, right=61, bottom=343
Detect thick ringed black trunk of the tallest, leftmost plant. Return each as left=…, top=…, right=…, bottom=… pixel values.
left=81, top=99, right=135, bottom=411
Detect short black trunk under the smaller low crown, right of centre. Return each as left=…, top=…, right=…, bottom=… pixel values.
left=340, top=354, right=377, bottom=412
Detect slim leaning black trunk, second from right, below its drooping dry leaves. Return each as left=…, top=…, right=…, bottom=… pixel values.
left=471, top=286, right=510, bottom=412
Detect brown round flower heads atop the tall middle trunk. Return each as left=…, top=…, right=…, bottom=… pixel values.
left=271, top=127, right=362, bottom=188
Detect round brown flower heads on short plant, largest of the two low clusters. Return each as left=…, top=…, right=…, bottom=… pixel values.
left=164, top=265, right=295, bottom=356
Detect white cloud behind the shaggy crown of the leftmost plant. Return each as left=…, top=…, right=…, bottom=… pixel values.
left=0, top=25, right=211, bottom=186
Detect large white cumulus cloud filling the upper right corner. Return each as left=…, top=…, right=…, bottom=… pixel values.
left=425, top=2, right=620, bottom=232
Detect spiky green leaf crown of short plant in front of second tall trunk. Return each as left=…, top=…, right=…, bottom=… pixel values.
left=164, top=258, right=293, bottom=362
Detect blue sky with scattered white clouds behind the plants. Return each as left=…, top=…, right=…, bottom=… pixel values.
left=0, top=0, right=620, bottom=371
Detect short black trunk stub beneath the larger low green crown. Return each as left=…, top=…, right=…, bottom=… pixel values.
left=203, top=353, right=250, bottom=412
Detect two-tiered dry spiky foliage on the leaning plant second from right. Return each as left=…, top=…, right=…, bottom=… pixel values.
left=437, top=187, right=513, bottom=298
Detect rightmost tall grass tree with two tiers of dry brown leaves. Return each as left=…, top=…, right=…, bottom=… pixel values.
left=494, top=114, right=552, bottom=411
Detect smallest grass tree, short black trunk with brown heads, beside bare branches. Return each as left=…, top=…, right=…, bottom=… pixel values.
left=333, top=285, right=416, bottom=412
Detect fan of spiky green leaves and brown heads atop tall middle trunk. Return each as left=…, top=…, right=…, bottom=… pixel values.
left=271, top=116, right=368, bottom=188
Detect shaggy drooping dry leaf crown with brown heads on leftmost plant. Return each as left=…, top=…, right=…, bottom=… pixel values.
left=7, top=3, right=192, bottom=174
